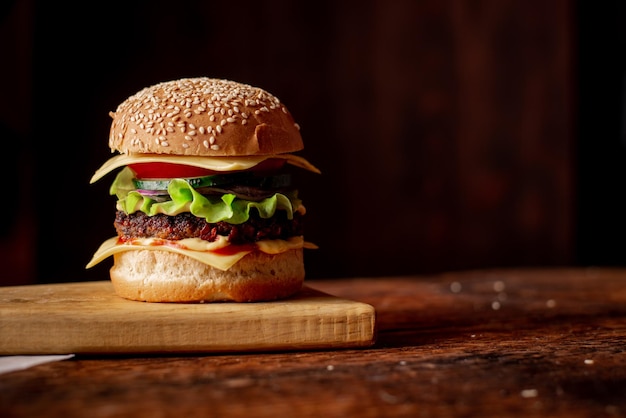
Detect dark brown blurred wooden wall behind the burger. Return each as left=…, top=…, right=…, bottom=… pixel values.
left=0, top=0, right=626, bottom=284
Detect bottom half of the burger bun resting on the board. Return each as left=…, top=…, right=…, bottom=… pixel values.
left=110, top=249, right=304, bottom=302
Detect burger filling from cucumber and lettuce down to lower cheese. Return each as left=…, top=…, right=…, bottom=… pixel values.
left=87, top=158, right=315, bottom=270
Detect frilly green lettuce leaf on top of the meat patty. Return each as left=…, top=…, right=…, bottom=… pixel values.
left=109, top=167, right=301, bottom=224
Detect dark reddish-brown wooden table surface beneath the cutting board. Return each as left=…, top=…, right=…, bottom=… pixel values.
left=0, top=268, right=626, bottom=418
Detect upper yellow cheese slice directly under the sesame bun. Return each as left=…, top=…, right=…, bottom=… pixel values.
left=90, top=154, right=320, bottom=183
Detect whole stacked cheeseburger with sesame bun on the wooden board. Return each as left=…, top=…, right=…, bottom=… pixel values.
left=87, top=78, right=319, bottom=302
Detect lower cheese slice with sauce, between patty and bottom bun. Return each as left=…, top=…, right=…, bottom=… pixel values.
left=87, top=237, right=317, bottom=270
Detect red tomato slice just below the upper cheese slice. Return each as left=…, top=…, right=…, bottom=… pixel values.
left=128, top=158, right=285, bottom=179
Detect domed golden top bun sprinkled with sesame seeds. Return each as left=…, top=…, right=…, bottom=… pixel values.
left=109, top=77, right=304, bottom=157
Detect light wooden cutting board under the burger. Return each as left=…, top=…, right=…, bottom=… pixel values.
left=0, top=281, right=375, bottom=355
